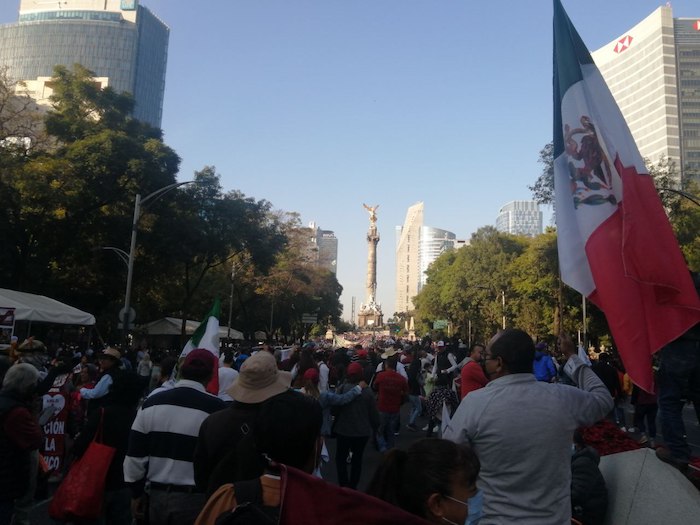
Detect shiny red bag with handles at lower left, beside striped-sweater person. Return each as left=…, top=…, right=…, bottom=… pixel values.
left=49, top=415, right=116, bottom=521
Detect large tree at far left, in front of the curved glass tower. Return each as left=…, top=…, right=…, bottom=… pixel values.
left=0, top=66, right=179, bottom=328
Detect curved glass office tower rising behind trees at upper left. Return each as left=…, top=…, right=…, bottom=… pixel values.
left=0, top=0, right=170, bottom=127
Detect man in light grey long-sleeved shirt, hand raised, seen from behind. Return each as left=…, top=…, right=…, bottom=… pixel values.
left=443, top=329, right=613, bottom=525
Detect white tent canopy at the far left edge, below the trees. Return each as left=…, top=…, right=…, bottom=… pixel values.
left=0, top=288, right=95, bottom=326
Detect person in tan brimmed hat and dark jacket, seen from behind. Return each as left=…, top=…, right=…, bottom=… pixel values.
left=194, top=352, right=292, bottom=494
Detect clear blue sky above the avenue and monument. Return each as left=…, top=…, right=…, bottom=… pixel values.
left=0, top=0, right=700, bottom=318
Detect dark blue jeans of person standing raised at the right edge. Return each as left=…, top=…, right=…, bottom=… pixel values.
left=658, top=340, right=700, bottom=461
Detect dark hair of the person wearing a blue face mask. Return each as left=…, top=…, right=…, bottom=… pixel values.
left=367, top=438, right=481, bottom=518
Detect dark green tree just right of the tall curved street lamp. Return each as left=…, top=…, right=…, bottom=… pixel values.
left=144, top=166, right=286, bottom=334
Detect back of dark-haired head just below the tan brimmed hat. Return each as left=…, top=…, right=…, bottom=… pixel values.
left=253, top=391, right=322, bottom=469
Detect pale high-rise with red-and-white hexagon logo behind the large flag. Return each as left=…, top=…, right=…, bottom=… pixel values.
left=592, top=5, right=700, bottom=181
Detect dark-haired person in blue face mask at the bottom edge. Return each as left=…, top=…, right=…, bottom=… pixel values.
left=367, top=438, right=482, bottom=525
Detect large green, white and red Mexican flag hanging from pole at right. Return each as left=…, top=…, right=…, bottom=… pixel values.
left=554, top=0, right=700, bottom=391
